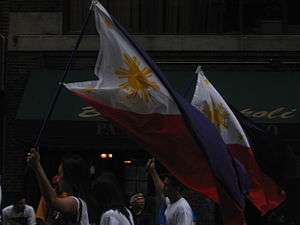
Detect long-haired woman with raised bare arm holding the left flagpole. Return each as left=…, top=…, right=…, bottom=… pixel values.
left=27, top=149, right=92, bottom=225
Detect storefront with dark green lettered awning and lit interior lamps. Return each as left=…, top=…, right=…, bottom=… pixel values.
left=13, top=63, right=300, bottom=207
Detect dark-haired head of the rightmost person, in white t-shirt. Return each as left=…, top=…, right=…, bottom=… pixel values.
left=163, top=175, right=183, bottom=197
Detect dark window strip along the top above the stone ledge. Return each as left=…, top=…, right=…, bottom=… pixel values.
left=64, top=0, right=300, bottom=35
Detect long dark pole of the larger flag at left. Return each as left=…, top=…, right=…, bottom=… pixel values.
left=34, top=0, right=94, bottom=149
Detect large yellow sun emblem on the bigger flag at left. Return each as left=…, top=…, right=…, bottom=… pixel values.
left=115, top=54, right=159, bottom=102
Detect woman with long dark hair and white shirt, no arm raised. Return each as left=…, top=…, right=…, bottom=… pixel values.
left=92, top=174, right=134, bottom=225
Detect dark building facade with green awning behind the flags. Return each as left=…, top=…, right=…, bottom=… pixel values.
left=0, top=0, right=300, bottom=220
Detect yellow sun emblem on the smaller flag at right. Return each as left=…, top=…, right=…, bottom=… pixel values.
left=203, top=104, right=229, bottom=129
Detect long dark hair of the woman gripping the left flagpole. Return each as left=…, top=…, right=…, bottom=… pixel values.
left=61, top=155, right=96, bottom=222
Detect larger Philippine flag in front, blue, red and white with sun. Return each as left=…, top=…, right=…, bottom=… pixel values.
left=65, top=2, right=248, bottom=225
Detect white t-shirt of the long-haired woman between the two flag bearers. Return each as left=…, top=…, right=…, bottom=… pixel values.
left=100, top=209, right=134, bottom=225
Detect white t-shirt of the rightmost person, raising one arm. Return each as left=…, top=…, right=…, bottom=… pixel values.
left=165, top=198, right=193, bottom=225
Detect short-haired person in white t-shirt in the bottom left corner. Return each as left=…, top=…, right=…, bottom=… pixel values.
left=2, top=194, right=36, bottom=225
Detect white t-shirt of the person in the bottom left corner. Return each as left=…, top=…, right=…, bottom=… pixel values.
left=2, top=205, right=36, bottom=225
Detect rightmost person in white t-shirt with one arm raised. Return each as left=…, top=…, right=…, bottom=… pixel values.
left=147, top=159, right=193, bottom=225
